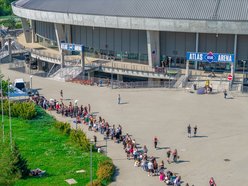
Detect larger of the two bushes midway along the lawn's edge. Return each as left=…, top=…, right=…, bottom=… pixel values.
left=70, top=129, right=90, bottom=151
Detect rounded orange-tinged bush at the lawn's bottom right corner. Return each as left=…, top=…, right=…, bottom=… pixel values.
left=97, top=160, right=115, bottom=185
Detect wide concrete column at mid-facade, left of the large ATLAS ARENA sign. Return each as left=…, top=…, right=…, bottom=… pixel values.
left=146, top=30, right=160, bottom=67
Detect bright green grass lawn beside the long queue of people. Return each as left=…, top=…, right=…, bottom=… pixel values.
left=1, top=109, right=107, bottom=186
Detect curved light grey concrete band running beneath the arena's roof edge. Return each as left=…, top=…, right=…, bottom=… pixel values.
left=12, top=3, right=248, bottom=35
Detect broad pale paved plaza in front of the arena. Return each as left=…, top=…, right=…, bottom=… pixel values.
left=1, top=64, right=248, bottom=186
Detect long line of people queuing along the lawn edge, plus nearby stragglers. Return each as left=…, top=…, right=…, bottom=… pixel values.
left=28, top=90, right=216, bottom=186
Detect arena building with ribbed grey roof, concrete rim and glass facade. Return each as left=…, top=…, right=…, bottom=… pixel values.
left=12, top=0, right=248, bottom=72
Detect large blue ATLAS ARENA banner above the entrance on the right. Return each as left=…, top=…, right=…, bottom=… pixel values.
left=186, top=52, right=234, bottom=63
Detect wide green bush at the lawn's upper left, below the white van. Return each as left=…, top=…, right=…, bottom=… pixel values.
left=0, top=100, right=37, bottom=119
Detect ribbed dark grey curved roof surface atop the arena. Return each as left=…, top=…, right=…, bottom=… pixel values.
left=15, top=0, right=248, bottom=21
